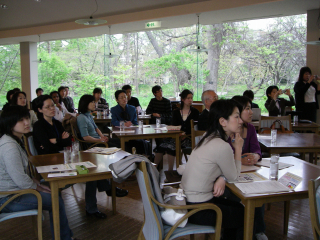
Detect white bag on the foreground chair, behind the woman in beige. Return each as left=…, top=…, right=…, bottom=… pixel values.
left=161, top=187, right=188, bottom=228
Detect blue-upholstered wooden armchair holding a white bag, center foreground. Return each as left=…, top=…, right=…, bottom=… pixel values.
left=136, top=162, right=222, bottom=240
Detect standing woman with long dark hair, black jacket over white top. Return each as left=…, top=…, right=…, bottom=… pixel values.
left=294, top=67, right=320, bottom=122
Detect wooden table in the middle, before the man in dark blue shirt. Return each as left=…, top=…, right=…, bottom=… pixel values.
left=112, top=124, right=183, bottom=168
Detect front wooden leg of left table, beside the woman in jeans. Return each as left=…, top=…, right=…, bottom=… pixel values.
left=50, top=181, right=60, bottom=240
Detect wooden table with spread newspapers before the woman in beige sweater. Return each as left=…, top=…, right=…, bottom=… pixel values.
left=227, top=157, right=320, bottom=240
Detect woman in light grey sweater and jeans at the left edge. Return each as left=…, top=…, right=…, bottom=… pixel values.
left=0, top=106, right=73, bottom=240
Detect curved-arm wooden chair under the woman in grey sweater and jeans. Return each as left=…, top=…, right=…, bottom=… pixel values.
left=0, top=189, right=42, bottom=240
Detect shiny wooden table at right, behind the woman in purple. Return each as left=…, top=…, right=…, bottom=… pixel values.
left=258, top=133, right=320, bottom=163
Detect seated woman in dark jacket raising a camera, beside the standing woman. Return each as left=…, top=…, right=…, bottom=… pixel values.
left=264, top=86, right=295, bottom=116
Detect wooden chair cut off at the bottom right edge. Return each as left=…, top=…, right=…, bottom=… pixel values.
left=309, top=177, right=320, bottom=240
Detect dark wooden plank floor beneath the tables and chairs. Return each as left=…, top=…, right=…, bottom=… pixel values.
left=0, top=175, right=313, bottom=240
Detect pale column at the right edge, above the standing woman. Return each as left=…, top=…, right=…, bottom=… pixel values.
left=301, top=9, right=320, bottom=124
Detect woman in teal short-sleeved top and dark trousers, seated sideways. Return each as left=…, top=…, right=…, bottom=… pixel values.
left=77, top=95, right=128, bottom=219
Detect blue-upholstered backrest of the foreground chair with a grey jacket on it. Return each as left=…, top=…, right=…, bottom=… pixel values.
left=136, top=162, right=164, bottom=240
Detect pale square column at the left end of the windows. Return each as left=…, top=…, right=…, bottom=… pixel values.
left=20, top=42, right=38, bottom=103
